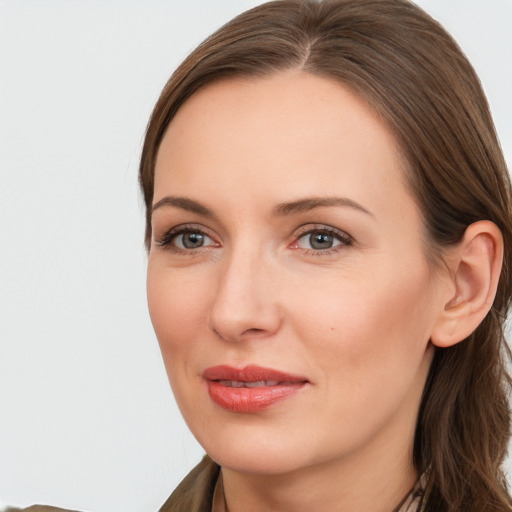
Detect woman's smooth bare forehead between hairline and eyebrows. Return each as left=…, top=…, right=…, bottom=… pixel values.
left=155, top=71, right=414, bottom=218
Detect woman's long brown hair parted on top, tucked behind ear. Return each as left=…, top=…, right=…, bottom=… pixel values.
left=140, top=0, right=512, bottom=512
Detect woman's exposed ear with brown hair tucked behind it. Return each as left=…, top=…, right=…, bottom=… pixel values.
left=431, top=221, right=503, bottom=347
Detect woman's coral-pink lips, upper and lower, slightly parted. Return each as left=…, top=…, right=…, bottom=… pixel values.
left=203, top=365, right=308, bottom=413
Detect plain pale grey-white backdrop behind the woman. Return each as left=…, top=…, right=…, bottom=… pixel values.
left=0, top=0, right=512, bottom=512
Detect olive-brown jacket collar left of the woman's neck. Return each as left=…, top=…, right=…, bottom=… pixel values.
left=159, top=456, right=220, bottom=512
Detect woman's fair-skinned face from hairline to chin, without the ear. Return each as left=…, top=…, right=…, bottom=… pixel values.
left=148, top=72, right=442, bottom=473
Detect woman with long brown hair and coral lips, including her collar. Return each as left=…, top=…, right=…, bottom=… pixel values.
left=140, top=0, right=512, bottom=512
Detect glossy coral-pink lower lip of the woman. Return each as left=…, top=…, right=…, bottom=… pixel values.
left=206, top=380, right=306, bottom=413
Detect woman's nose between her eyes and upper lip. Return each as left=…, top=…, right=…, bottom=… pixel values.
left=209, top=245, right=282, bottom=342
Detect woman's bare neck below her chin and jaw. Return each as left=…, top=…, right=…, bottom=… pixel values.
left=222, top=432, right=418, bottom=512
